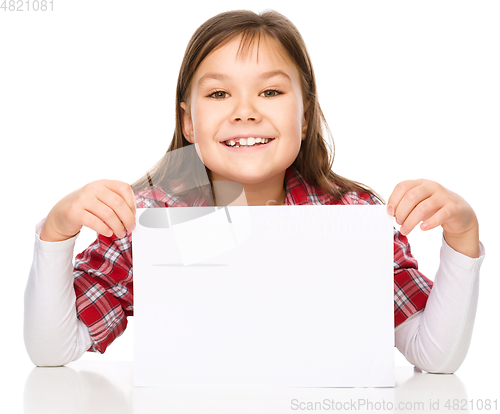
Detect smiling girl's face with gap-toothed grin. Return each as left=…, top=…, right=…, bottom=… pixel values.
left=181, top=37, right=307, bottom=186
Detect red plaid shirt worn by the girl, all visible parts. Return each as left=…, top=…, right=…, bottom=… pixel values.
left=74, top=167, right=433, bottom=353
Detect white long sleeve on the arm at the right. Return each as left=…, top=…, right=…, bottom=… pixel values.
left=395, top=238, right=484, bottom=374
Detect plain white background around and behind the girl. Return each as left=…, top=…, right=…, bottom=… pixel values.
left=0, top=0, right=500, bottom=408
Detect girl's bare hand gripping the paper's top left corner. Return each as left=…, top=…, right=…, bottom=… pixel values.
left=40, top=180, right=136, bottom=242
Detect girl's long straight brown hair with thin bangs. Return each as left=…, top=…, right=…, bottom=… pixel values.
left=132, top=10, right=382, bottom=200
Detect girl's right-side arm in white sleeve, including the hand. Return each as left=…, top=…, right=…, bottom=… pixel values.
left=387, top=180, right=484, bottom=373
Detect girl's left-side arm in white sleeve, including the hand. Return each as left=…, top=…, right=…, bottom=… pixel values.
left=24, top=180, right=135, bottom=366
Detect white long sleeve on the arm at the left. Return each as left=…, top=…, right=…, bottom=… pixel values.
left=24, top=221, right=92, bottom=366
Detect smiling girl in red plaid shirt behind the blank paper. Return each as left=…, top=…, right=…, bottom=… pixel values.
left=25, top=11, right=484, bottom=373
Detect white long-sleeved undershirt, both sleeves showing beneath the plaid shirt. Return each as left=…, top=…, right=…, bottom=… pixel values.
left=24, top=222, right=484, bottom=373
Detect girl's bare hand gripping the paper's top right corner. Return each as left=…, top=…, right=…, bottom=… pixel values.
left=387, top=180, right=480, bottom=257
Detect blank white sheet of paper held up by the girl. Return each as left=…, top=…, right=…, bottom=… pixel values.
left=132, top=205, right=395, bottom=387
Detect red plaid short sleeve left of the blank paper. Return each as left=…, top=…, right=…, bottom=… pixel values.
left=74, top=232, right=133, bottom=353
